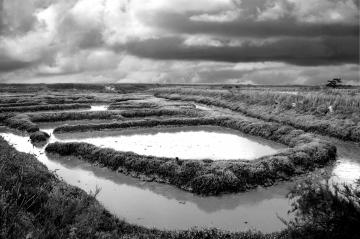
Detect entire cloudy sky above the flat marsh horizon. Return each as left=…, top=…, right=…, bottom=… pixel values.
left=0, top=0, right=360, bottom=85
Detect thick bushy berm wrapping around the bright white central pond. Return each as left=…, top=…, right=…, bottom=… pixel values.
left=46, top=118, right=336, bottom=195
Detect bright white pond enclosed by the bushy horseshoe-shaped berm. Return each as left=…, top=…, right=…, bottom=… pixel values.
left=50, top=126, right=284, bottom=160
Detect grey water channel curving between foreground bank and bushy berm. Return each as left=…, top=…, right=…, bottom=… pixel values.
left=0, top=129, right=290, bottom=232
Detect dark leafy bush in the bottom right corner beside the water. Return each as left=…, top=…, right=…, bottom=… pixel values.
left=286, top=180, right=360, bottom=239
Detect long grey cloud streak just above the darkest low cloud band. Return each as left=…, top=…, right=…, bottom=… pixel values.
left=143, top=12, right=359, bottom=37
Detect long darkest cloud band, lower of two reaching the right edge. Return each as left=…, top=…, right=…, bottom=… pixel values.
left=126, top=37, right=359, bottom=66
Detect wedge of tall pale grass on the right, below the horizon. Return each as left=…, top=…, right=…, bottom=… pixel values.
left=153, top=88, right=360, bottom=142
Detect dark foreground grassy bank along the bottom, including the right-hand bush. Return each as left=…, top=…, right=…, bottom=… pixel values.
left=0, top=137, right=360, bottom=239
